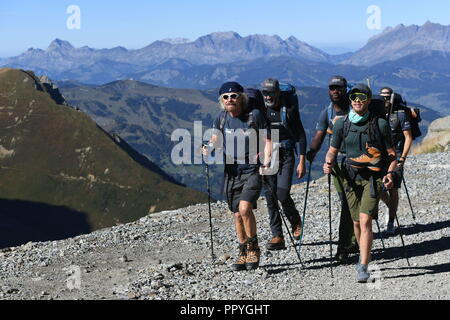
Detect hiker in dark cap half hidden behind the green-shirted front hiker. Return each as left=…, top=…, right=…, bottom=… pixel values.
left=306, top=76, right=357, bottom=263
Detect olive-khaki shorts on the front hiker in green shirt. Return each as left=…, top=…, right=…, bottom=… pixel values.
left=344, top=179, right=382, bottom=221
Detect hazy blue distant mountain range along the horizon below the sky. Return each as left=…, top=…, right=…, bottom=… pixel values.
left=0, top=22, right=450, bottom=115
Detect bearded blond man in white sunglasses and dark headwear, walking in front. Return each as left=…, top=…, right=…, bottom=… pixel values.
left=203, top=82, right=271, bottom=271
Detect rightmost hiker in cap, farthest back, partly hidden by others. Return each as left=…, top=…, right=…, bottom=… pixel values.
left=380, top=87, right=413, bottom=234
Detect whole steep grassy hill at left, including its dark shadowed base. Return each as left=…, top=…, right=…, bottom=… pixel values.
left=0, top=68, right=206, bottom=246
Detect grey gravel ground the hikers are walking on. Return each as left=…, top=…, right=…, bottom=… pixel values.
left=0, top=152, right=450, bottom=300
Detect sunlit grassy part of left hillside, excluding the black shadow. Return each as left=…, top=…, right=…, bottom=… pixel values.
left=0, top=69, right=206, bottom=229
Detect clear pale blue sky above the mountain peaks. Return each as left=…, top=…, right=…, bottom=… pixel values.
left=0, top=0, right=450, bottom=57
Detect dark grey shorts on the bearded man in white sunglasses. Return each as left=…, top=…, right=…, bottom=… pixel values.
left=225, top=171, right=262, bottom=213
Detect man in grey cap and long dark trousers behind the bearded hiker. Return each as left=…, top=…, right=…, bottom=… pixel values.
left=262, top=78, right=306, bottom=250
